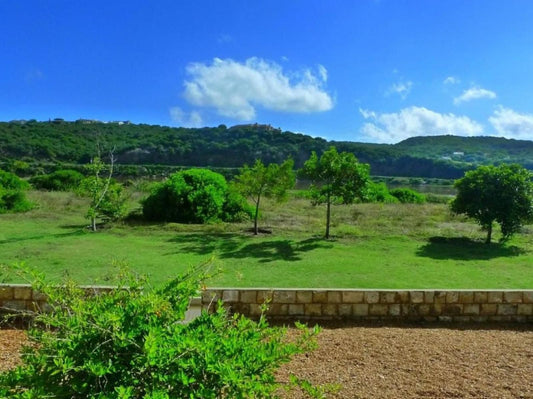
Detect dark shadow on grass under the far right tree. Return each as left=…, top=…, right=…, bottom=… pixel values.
left=416, top=237, right=526, bottom=260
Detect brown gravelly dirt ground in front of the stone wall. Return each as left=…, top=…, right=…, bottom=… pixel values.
left=0, top=324, right=533, bottom=399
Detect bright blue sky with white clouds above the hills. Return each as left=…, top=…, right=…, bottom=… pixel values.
left=0, top=0, right=533, bottom=143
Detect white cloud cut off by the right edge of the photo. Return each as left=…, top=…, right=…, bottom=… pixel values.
left=489, top=106, right=533, bottom=140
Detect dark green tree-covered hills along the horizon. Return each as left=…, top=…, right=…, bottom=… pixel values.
left=0, top=119, right=533, bottom=179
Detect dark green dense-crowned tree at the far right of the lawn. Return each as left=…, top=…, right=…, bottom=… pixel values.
left=451, top=164, right=533, bottom=243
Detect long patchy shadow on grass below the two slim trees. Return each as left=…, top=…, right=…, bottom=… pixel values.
left=169, top=233, right=332, bottom=263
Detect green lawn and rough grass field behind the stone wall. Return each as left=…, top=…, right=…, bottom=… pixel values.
left=0, top=192, right=533, bottom=289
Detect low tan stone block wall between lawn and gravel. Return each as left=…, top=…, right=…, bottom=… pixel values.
left=0, top=284, right=533, bottom=322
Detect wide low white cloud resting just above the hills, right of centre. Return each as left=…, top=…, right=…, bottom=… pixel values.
left=359, top=107, right=483, bottom=143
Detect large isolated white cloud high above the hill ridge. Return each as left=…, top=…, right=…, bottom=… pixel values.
left=184, top=57, right=333, bottom=120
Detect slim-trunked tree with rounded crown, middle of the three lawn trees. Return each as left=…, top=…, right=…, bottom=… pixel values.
left=300, top=147, right=370, bottom=238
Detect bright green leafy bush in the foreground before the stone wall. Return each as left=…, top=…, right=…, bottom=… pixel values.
left=0, top=270, right=320, bottom=399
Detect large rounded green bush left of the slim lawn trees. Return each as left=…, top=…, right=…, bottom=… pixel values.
left=143, top=169, right=250, bottom=223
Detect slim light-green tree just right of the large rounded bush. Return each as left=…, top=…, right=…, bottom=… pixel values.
left=235, top=159, right=296, bottom=235
